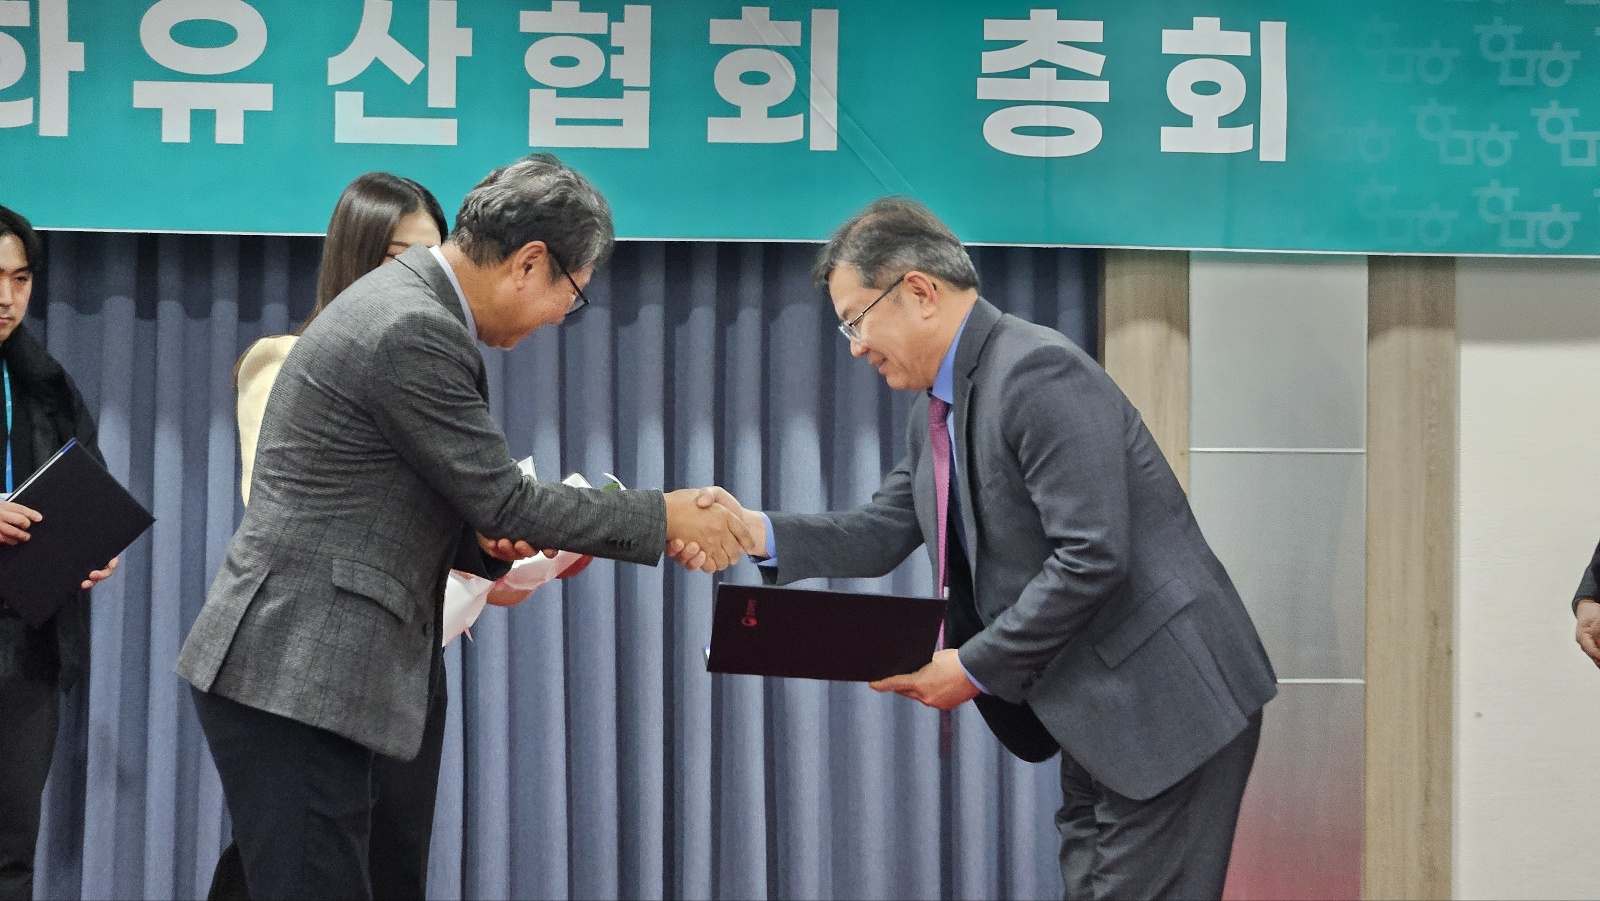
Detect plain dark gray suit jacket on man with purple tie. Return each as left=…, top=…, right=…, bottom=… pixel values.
left=771, top=299, right=1277, bottom=800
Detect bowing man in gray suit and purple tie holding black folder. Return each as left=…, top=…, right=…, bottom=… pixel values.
left=688, top=198, right=1277, bottom=899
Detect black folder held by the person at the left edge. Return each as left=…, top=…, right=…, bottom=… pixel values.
left=0, top=440, right=155, bottom=627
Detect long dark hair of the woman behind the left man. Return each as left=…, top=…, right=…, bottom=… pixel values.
left=305, top=173, right=450, bottom=334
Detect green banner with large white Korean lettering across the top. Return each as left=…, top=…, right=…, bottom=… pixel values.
left=0, top=0, right=1600, bottom=254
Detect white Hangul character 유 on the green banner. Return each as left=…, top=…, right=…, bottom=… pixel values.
left=133, top=0, right=272, bottom=144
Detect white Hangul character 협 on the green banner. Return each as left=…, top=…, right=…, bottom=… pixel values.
left=520, top=0, right=650, bottom=147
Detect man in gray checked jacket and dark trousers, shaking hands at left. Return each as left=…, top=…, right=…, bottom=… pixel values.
left=178, top=154, right=749, bottom=901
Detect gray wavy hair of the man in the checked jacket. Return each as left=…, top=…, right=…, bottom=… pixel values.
left=450, top=154, right=616, bottom=272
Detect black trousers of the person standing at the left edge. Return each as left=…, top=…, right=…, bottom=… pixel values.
left=0, top=677, right=61, bottom=901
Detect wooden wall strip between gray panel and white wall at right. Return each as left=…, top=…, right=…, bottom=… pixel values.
left=1362, top=256, right=1459, bottom=898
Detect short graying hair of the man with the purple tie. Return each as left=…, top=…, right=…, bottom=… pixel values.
left=811, top=197, right=978, bottom=291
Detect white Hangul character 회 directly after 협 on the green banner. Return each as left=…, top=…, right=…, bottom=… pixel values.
left=706, top=6, right=838, bottom=150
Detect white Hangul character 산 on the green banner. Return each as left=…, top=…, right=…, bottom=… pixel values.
left=328, top=0, right=472, bottom=146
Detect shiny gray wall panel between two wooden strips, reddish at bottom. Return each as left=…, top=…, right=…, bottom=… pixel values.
left=1189, top=253, right=1366, bottom=898
